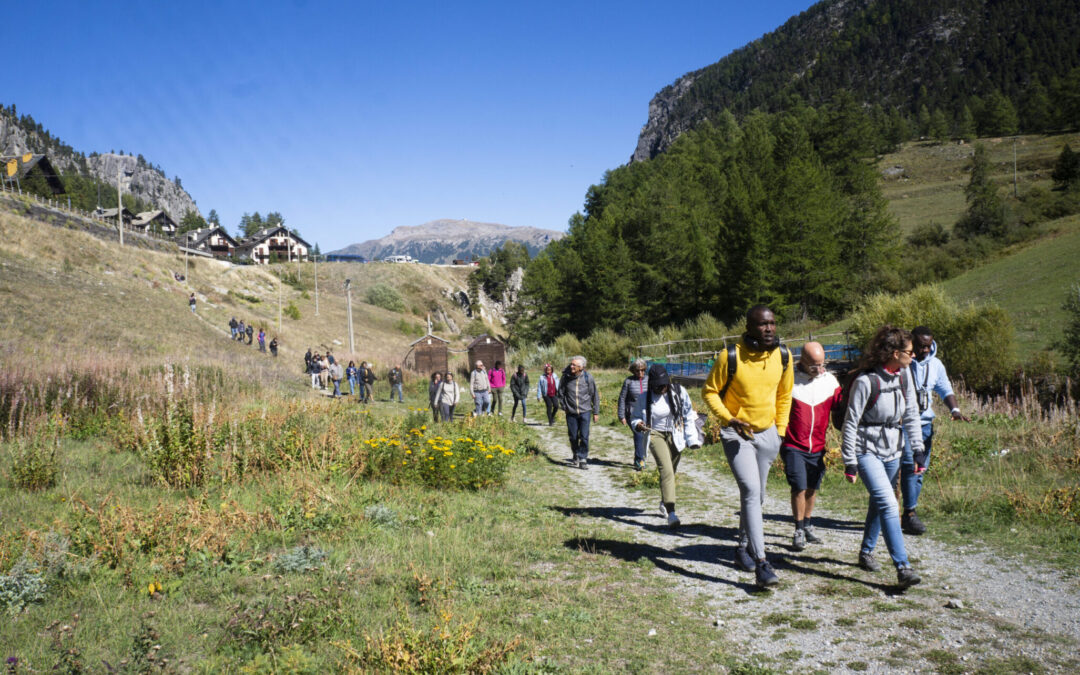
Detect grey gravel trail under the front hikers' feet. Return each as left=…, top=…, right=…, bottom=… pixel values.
left=537, top=424, right=1080, bottom=673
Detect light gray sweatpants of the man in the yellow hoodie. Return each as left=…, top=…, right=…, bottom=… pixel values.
left=720, top=426, right=780, bottom=561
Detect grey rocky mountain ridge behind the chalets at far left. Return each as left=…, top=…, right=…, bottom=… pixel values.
left=0, top=106, right=199, bottom=222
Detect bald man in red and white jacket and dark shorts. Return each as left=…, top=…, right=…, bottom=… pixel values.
left=780, top=342, right=840, bottom=551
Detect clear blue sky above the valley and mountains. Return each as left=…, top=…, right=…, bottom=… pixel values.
left=0, top=0, right=811, bottom=251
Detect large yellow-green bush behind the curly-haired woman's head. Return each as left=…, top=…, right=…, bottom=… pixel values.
left=851, top=285, right=1016, bottom=393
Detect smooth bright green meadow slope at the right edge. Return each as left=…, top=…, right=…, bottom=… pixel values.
left=943, top=215, right=1080, bottom=352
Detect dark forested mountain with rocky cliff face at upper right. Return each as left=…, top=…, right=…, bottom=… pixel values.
left=631, top=0, right=1080, bottom=161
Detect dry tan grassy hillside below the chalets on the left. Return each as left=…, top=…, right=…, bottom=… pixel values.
left=0, top=201, right=468, bottom=373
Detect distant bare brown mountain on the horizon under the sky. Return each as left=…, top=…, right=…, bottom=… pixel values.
left=332, top=219, right=564, bottom=262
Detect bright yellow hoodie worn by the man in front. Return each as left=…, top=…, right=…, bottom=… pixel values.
left=702, top=340, right=795, bottom=438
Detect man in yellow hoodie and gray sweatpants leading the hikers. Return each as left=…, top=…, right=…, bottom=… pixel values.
left=702, top=305, right=794, bottom=586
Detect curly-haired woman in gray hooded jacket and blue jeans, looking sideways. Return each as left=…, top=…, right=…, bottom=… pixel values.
left=841, top=326, right=926, bottom=589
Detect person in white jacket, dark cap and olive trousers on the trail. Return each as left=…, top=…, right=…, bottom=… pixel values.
left=630, top=363, right=701, bottom=527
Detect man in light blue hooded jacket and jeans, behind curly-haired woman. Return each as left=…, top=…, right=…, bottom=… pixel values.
left=900, top=326, right=970, bottom=535
